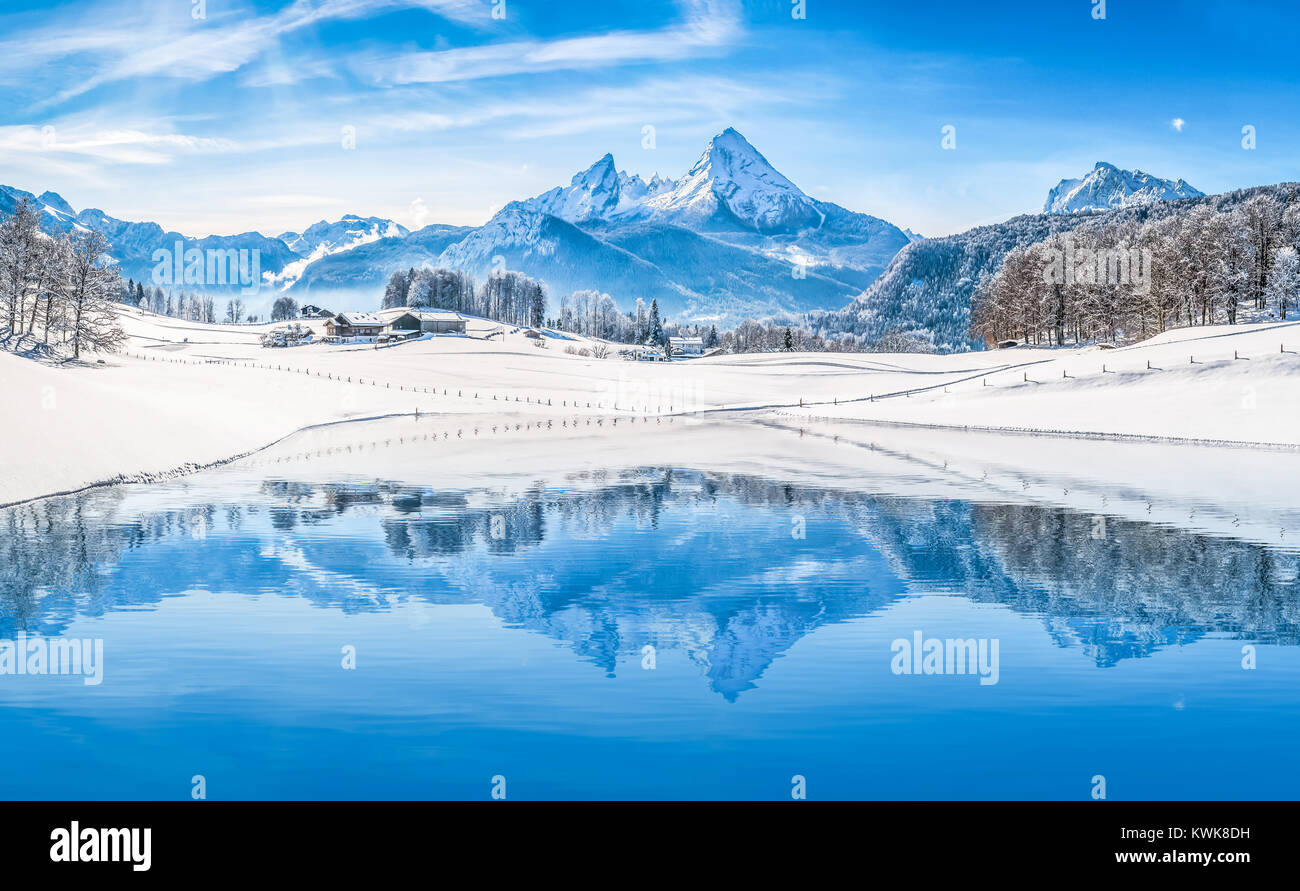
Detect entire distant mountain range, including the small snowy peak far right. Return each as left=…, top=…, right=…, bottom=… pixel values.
left=0, top=147, right=1203, bottom=338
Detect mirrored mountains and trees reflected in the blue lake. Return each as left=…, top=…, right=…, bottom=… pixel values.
left=0, top=468, right=1300, bottom=700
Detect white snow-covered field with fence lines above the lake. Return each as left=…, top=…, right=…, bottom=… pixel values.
left=0, top=310, right=1300, bottom=503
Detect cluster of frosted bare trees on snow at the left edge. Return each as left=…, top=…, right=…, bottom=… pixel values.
left=0, top=199, right=126, bottom=358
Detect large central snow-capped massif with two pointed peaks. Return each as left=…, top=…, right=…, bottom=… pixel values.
left=421, top=127, right=909, bottom=320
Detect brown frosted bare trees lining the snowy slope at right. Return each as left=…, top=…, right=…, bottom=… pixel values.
left=971, top=194, right=1300, bottom=345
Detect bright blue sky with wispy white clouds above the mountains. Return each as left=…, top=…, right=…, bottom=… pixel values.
left=0, top=0, right=1300, bottom=235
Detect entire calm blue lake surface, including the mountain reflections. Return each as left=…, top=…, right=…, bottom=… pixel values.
left=0, top=457, right=1300, bottom=800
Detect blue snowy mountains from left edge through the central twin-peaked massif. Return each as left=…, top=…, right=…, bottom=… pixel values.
left=0, top=127, right=910, bottom=324
